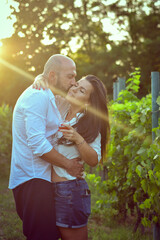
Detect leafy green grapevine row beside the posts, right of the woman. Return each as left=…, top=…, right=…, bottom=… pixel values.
left=88, top=69, right=160, bottom=230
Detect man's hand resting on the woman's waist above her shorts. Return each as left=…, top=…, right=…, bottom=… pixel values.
left=66, top=158, right=84, bottom=178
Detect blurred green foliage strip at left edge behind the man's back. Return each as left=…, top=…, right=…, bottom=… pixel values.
left=0, top=105, right=12, bottom=176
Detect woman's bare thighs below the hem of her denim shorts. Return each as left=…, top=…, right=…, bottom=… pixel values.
left=59, top=226, right=88, bottom=240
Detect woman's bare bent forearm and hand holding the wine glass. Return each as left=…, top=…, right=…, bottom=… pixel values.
left=60, top=124, right=98, bottom=167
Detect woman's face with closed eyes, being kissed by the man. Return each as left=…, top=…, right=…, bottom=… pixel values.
left=66, top=78, right=93, bottom=105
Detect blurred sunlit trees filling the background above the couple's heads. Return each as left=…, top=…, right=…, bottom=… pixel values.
left=0, top=0, right=160, bottom=106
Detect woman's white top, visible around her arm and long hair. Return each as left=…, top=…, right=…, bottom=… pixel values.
left=53, top=95, right=101, bottom=180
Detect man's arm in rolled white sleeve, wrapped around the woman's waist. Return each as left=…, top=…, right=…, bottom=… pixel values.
left=24, top=90, right=83, bottom=177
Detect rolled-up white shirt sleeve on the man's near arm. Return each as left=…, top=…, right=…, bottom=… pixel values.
left=24, top=91, right=53, bottom=157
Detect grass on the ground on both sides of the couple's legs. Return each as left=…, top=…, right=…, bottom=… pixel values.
left=0, top=174, right=153, bottom=240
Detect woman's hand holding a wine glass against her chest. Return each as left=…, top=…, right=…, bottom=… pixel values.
left=59, top=123, right=84, bottom=145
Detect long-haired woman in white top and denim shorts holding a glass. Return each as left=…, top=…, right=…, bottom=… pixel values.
left=33, top=75, right=110, bottom=240
